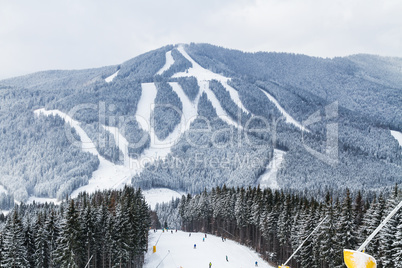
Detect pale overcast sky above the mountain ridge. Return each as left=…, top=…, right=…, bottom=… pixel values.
left=0, top=0, right=402, bottom=79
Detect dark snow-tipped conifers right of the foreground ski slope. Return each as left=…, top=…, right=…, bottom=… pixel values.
left=177, top=186, right=402, bottom=268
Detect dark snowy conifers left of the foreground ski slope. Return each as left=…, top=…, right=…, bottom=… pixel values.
left=0, top=187, right=150, bottom=268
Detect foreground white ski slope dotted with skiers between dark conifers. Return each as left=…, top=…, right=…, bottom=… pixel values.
left=144, top=230, right=273, bottom=268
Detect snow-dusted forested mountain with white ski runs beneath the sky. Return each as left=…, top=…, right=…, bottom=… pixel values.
left=0, top=44, right=402, bottom=203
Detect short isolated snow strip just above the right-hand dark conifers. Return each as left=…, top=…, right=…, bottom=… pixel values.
left=259, top=149, right=286, bottom=190
